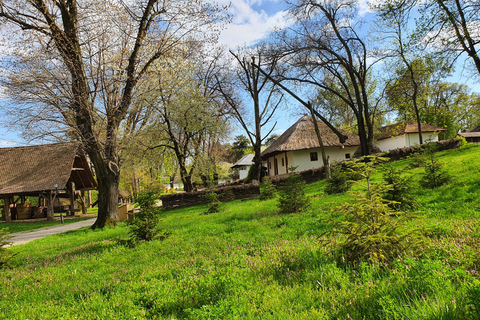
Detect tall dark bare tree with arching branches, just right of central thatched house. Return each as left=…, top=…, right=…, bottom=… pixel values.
left=276, top=0, right=384, bottom=155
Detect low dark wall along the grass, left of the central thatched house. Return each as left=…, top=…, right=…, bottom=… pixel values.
left=161, top=183, right=260, bottom=210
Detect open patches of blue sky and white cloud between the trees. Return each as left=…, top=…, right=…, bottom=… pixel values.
left=0, top=0, right=480, bottom=147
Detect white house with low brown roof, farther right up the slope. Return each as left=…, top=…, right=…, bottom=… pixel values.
left=375, top=121, right=447, bottom=151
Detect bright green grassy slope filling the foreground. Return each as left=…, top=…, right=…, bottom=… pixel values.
left=0, top=146, right=480, bottom=319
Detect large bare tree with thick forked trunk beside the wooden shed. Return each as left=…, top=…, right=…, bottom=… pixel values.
left=0, top=0, right=228, bottom=228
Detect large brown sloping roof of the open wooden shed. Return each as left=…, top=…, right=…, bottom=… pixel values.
left=0, top=143, right=97, bottom=195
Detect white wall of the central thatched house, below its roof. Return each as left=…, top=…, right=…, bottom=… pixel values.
left=267, top=147, right=358, bottom=177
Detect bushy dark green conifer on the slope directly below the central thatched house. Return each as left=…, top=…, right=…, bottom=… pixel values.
left=278, top=173, right=309, bottom=213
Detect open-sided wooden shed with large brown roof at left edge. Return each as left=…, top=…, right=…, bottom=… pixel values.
left=0, top=143, right=97, bottom=221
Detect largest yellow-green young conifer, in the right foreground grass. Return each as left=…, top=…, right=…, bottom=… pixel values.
left=326, top=166, right=420, bottom=265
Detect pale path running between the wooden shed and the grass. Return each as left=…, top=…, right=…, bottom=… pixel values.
left=8, top=218, right=95, bottom=246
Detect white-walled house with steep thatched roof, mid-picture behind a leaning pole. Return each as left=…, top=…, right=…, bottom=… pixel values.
left=262, top=116, right=360, bottom=176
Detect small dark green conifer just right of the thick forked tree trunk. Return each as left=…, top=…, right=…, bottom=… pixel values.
left=127, top=190, right=165, bottom=243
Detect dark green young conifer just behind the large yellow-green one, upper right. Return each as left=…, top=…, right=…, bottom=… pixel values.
left=382, top=166, right=414, bottom=211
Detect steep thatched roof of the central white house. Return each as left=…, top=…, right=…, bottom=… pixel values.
left=262, top=116, right=360, bottom=159
